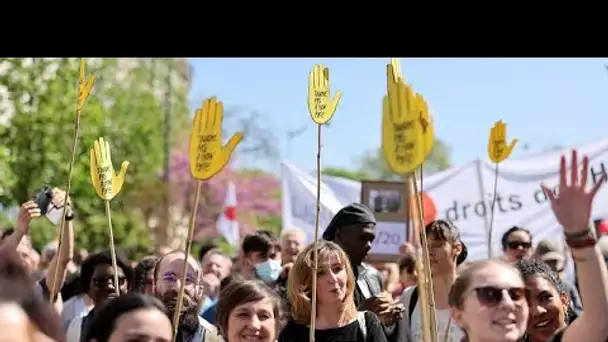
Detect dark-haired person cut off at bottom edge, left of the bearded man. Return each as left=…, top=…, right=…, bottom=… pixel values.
left=84, top=292, right=171, bottom=342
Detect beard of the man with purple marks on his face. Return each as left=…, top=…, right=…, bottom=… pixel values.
left=158, top=290, right=200, bottom=341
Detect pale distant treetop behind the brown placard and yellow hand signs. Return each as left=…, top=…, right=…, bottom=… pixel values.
left=360, top=139, right=450, bottom=180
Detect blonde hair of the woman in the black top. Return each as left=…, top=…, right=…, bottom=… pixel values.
left=287, top=240, right=357, bottom=326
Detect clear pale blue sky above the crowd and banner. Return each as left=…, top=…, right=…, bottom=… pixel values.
left=190, top=58, right=608, bottom=171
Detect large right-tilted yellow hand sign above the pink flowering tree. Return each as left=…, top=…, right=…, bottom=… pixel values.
left=190, top=97, right=243, bottom=180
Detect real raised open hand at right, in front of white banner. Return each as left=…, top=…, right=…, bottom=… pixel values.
left=541, top=150, right=606, bottom=233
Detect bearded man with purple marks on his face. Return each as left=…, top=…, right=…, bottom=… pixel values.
left=154, top=251, right=217, bottom=341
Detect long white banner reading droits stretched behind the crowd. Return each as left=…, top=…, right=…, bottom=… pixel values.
left=282, top=139, right=608, bottom=260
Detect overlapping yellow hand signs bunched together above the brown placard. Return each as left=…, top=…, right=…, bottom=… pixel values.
left=382, top=62, right=425, bottom=174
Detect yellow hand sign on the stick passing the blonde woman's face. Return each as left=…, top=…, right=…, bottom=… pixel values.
left=308, top=64, right=342, bottom=125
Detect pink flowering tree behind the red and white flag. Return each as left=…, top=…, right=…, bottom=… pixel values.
left=170, top=151, right=281, bottom=239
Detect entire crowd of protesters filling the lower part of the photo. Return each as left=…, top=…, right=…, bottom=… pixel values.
left=0, top=152, right=608, bottom=342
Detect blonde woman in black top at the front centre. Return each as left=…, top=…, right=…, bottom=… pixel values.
left=278, top=240, right=386, bottom=342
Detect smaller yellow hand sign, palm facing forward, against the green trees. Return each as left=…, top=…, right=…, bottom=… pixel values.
left=89, top=138, right=129, bottom=201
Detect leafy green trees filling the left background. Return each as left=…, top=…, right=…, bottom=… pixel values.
left=0, top=58, right=187, bottom=255
